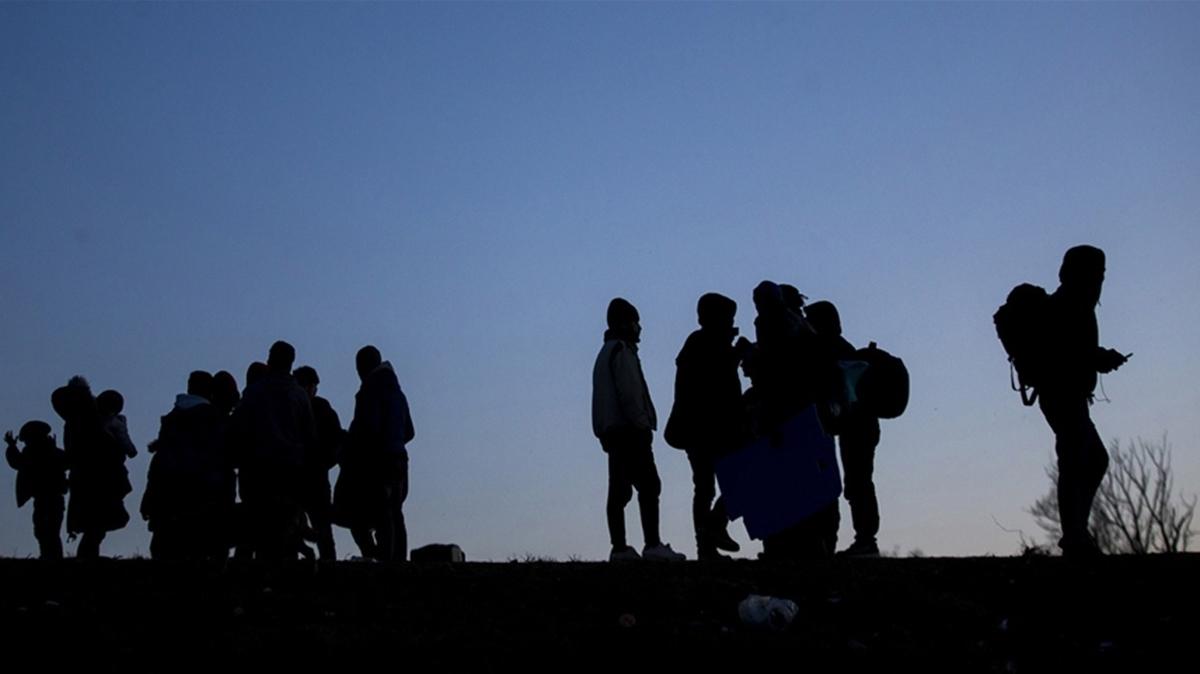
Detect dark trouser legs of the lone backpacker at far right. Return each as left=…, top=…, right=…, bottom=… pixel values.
left=1040, top=393, right=1109, bottom=548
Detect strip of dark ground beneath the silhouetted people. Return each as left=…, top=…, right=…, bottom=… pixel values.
left=0, top=554, right=1200, bottom=673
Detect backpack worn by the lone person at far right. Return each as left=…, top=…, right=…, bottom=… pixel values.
left=992, top=283, right=1050, bottom=405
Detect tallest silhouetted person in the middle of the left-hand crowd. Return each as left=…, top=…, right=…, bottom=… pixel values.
left=228, top=342, right=317, bottom=560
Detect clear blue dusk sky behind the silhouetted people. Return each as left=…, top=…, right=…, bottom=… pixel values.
left=0, top=2, right=1200, bottom=560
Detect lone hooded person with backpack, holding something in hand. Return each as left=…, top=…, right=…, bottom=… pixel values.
left=995, top=246, right=1132, bottom=556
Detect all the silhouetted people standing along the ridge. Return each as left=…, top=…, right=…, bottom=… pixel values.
left=5, top=246, right=1129, bottom=561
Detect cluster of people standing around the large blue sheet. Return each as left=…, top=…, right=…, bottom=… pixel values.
left=592, top=281, right=880, bottom=561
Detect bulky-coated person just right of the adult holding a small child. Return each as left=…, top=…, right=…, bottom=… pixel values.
left=142, top=371, right=232, bottom=559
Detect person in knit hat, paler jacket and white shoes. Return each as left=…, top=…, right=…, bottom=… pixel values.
left=592, top=297, right=684, bottom=561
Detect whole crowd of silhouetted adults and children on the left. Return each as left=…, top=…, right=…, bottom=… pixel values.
left=5, top=342, right=414, bottom=561
